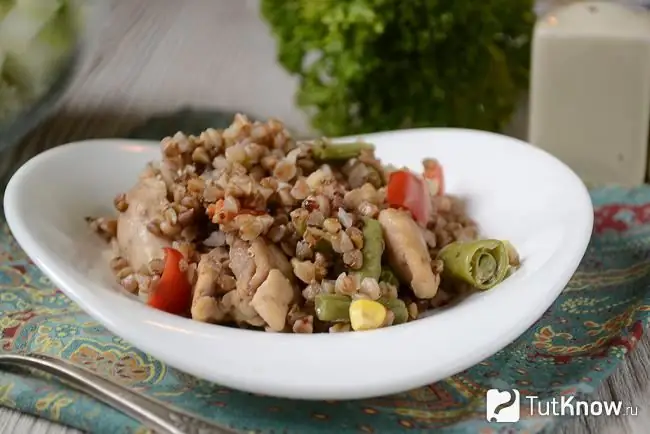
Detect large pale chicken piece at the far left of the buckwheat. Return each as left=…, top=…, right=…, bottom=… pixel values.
left=117, top=178, right=171, bottom=271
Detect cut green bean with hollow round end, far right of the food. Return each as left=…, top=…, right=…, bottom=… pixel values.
left=438, top=240, right=509, bottom=290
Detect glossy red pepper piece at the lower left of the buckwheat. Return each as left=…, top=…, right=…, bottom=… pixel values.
left=147, top=247, right=192, bottom=315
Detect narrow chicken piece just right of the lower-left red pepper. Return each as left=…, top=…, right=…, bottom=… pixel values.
left=191, top=249, right=233, bottom=322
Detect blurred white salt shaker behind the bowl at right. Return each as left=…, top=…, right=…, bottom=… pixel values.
left=528, top=0, right=650, bottom=185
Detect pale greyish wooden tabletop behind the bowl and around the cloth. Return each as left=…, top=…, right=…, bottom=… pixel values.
left=0, top=0, right=650, bottom=434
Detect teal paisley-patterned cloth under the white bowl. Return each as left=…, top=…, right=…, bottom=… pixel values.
left=0, top=187, right=650, bottom=434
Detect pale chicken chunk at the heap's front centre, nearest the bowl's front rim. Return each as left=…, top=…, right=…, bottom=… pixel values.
left=251, top=269, right=296, bottom=332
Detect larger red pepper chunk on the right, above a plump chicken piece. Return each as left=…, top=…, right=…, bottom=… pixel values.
left=386, top=170, right=431, bottom=226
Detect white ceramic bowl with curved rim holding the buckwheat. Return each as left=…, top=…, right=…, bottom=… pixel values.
left=4, top=129, right=593, bottom=399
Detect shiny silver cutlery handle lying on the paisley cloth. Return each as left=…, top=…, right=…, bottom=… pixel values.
left=0, top=354, right=237, bottom=434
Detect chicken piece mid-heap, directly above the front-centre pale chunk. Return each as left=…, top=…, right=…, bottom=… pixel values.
left=230, top=238, right=293, bottom=296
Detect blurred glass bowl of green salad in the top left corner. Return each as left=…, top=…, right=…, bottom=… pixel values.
left=0, top=0, right=93, bottom=150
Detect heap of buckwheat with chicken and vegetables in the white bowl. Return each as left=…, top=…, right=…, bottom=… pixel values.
left=95, top=114, right=519, bottom=333
